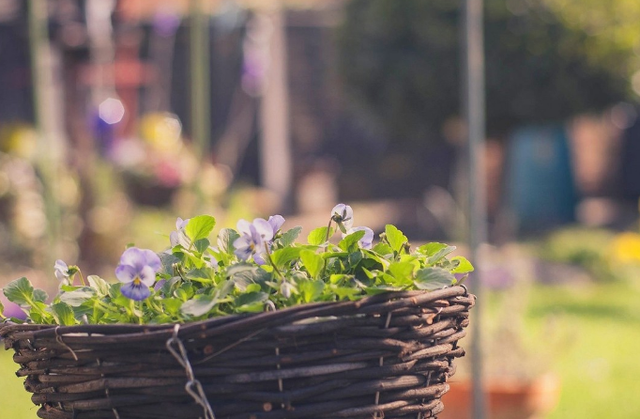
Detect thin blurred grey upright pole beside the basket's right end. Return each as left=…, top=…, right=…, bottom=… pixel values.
left=463, top=0, right=487, bottom=419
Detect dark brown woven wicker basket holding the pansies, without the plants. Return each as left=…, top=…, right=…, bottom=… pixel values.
left=0, top=286, right=475, bottom=419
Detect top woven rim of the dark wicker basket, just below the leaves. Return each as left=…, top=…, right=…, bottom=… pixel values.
left=0, top=285, right=475, bottom=339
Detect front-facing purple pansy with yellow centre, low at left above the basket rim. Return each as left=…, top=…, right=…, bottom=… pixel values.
left=116, top=247, right=162, bottom=301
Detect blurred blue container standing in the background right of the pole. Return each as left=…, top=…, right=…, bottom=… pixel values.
left=506, top=124, right=576, bottom=232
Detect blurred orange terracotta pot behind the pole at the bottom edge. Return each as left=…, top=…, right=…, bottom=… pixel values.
left=438, top=374, right=560, bottom=419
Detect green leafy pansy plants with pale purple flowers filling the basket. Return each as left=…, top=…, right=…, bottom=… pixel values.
left=0, top=204, right=473, bottom=325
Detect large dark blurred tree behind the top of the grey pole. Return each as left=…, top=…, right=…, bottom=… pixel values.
left=338, top=0, right=640, bottom=144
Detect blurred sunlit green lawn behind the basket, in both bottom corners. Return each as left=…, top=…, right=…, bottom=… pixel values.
left=0, top=283, right=640, bottom=419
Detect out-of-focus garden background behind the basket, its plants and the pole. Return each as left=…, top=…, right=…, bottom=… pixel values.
left=0, top=0, right=640, bottom=419
